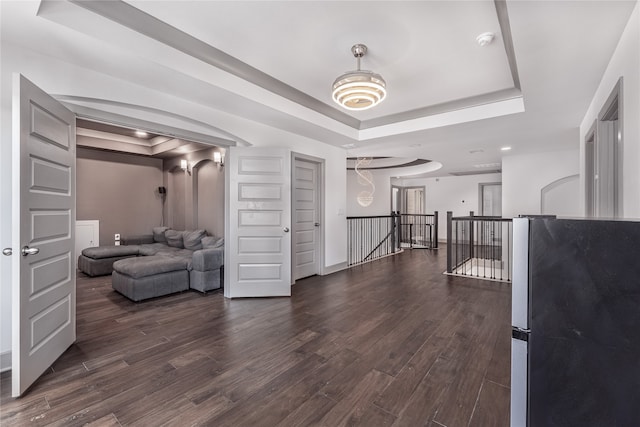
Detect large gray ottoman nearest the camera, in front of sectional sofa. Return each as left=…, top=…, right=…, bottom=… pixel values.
left=111, top=256, right=189, bottom=301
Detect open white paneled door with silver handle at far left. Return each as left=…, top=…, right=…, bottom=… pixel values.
left=11, top=74, right=76, bottom=397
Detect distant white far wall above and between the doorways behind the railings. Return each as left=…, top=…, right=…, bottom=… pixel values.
left=400, top=173, right=502, bottom=241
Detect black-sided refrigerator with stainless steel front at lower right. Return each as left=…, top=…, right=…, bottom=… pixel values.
left=511, top=218, right=640, bottom=427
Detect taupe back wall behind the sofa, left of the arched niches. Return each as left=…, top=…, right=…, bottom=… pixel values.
left=76, top=147, right=164, bottom=245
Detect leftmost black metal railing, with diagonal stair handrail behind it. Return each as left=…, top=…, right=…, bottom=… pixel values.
left=347, top=214, right=400, bottom=266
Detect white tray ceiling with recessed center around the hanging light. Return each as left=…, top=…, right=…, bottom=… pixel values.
left=0, top=0, right=635, bottom=176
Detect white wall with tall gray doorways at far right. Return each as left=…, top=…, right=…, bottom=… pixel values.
left=579, top=3, right=640, bottom=218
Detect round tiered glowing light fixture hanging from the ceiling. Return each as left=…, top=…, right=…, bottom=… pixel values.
left=331, top=44, right=387, bottom=110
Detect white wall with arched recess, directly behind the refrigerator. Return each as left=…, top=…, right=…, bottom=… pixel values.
left=502, top=149, right=581, bottom=217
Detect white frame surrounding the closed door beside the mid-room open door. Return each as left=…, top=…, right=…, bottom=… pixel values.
left=290, top=151, right=325, bottom=285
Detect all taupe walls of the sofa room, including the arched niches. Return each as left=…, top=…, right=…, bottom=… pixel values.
left=76, top=147, right=224, bottom=245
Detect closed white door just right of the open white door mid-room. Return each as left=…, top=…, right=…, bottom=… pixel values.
left=293, top=159, right=320, bottom=280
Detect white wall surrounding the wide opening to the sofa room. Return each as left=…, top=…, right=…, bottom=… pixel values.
left=0, top=42, right=347, bottom=364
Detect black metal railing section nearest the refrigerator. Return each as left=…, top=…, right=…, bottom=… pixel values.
left=447, top=212, right=513, bottom=282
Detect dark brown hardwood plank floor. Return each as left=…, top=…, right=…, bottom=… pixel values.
left=0, top=249, right=511, bottom=427
